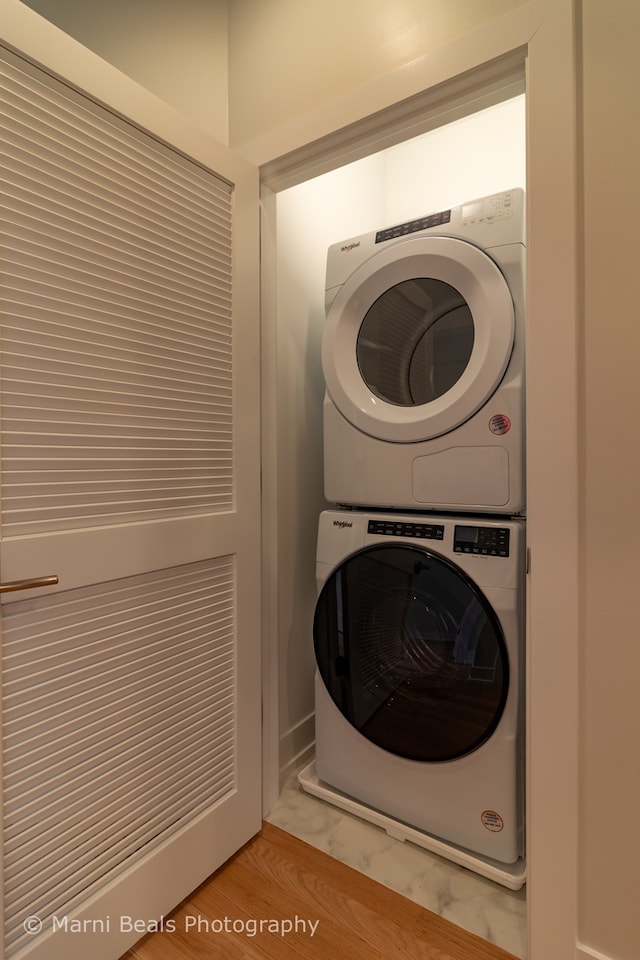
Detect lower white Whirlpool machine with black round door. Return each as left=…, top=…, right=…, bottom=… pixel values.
left=314, top=511, right=525, bottom=872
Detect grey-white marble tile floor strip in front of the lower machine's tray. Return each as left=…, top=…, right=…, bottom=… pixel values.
left=266, top=761, right=527, bottom=958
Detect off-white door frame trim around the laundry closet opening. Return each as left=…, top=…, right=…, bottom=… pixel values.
left=256, top=0, right=581, bottom=960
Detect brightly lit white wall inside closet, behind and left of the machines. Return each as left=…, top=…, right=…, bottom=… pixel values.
left=276, top=96, right=526, bottom=774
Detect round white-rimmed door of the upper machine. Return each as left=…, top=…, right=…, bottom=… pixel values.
left=322, top=237, right=515, bottom=443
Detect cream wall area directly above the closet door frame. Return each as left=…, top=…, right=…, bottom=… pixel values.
left=229, top=0, right=525, bottom=146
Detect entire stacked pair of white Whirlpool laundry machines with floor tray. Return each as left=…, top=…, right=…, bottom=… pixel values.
left=300, top=189, right=526, bottom=889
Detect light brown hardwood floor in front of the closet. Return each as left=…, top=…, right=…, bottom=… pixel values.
left=122, top=823, right=513, bottom=960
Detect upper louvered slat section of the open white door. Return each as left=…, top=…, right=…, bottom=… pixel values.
left=0, top=48, right=233, bottom=536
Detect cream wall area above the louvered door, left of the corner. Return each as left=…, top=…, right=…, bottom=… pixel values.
left=16, top=0, right=229, bottom=143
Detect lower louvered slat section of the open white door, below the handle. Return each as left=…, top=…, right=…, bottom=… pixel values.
left=3, top=557, right=235, bottom=950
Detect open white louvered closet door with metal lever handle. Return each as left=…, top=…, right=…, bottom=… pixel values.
left=0, top=37, right=260, bottom=960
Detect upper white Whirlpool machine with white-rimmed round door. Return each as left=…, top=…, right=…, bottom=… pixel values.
left=322, top=189, right=525, bottom=514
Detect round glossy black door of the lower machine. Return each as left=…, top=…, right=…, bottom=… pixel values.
left=313, top=543, right=509, bottom=762
